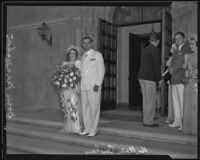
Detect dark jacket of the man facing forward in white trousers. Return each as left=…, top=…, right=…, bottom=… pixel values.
left=170, top=42, right=191, bottom=84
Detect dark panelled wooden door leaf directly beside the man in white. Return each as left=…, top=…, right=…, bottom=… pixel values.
left=99, top=19, right=117, bottom=110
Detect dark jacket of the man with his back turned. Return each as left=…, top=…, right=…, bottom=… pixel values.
left=138, top=44, right=161, bottom=82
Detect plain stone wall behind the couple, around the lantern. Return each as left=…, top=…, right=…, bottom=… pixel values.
left=7, top=6, right=113, bottom=109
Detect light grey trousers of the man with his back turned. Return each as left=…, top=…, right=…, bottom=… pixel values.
left=139, top=80, right=156, bottom=124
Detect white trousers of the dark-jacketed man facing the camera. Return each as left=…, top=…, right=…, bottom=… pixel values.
left=172, top=84, right=184, bottom=127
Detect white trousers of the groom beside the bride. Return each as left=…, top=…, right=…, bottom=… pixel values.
left=81, top=89, right=101, bottom=133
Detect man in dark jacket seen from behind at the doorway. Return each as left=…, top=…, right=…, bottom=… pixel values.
left=138, top=34, right=161, bottom=127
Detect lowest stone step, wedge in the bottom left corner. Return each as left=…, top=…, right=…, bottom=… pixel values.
left=7, top=134, right=90, bottom=154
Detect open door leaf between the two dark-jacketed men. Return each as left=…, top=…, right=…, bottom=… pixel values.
left=160, top=8, right=172, bottom=116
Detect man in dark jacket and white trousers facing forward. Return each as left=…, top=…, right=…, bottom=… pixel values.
left=169, top=32, right=191, bottom=130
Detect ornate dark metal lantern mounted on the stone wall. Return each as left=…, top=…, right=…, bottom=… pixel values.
left=38, top=22, right=52, bottom=46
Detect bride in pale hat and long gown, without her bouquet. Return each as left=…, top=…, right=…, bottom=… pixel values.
left=60, top=46, right=82, bottom=133
